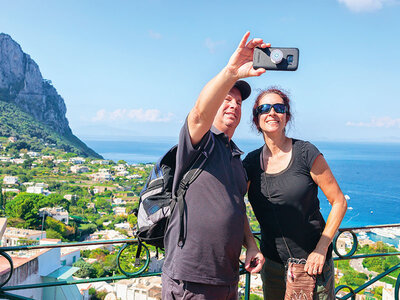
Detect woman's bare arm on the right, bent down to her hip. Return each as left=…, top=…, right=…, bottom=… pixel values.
left=304, top=155, right=347, bottom=275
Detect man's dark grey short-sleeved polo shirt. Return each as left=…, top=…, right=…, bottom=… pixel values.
left=163, top=120, right=247, bottom=285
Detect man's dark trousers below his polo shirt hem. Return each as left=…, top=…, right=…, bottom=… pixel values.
left=161, top=274, right=238, bottom=300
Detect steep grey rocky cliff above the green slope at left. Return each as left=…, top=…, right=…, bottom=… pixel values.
left=0, top=33, right=99, bottom=156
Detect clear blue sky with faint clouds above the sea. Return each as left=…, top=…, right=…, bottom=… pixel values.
left=0, top=0, right=400, bottom=143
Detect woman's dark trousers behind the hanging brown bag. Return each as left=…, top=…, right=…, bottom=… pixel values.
left=261, top=259, right=335, bottom=300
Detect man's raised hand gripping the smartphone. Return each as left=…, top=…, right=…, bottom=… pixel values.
left=226, top=32, right=271, bottom=79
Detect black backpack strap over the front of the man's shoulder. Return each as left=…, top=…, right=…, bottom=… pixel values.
left=173, top=133, right=215, bottom=248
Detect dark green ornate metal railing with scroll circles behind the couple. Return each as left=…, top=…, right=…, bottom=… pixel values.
left=0, top=224, right=400, bottom=300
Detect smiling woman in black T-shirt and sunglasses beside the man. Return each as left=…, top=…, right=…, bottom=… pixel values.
left=243, top=88, right=347, bottom=300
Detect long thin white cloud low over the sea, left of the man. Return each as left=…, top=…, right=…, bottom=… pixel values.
left=91, top=108, right=174, bottom=123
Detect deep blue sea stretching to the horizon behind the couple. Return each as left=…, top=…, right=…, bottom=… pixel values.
left=87, top=138, right=400, bottom=227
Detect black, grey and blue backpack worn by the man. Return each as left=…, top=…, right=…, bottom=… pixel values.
left=136, top=134, right=214, bottom=249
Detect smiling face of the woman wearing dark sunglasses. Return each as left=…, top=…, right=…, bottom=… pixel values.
left=258, top=93, right=288, bottom=134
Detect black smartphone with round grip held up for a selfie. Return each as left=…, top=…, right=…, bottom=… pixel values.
left=253, top=47, right=299, bottom=71
